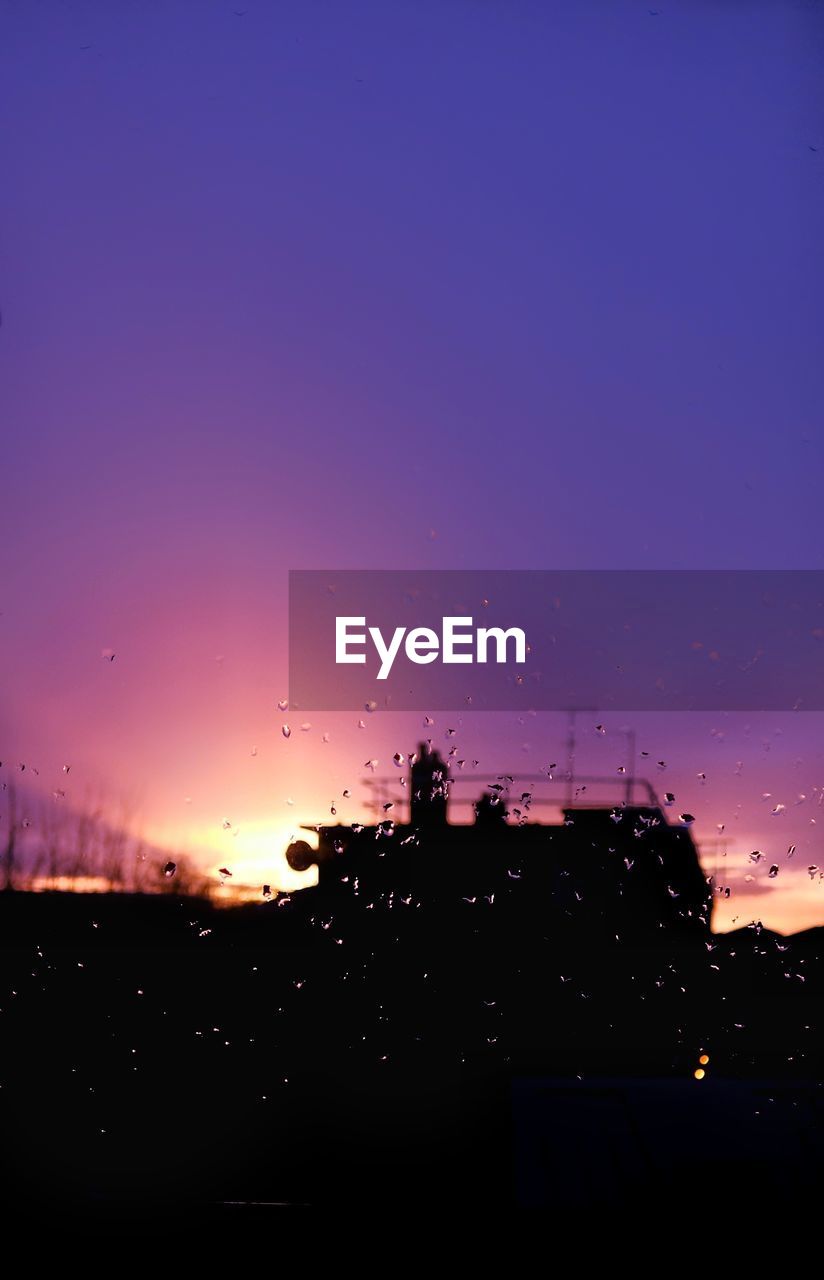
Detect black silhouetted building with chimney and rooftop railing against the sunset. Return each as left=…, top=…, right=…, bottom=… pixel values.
left=287, top=744, right=713, bottom=938
